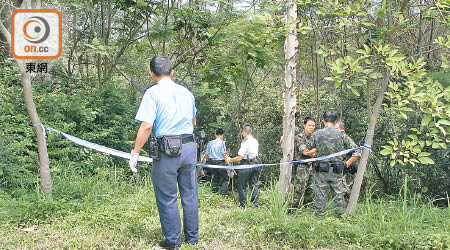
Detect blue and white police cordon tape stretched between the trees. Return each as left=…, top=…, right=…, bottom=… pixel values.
left=42, top=126, right=372, bottom=170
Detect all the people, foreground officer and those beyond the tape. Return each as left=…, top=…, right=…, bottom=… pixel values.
left=129, top=56, right=358, bottom=249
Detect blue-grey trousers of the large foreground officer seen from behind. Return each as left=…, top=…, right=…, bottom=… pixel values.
left=152, top=142, right=198, bottom=245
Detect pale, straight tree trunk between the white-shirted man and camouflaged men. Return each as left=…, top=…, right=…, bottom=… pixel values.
left=279, top=0, right=298, bottom=195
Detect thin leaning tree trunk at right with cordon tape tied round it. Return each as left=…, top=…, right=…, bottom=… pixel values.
left=345, top=69, right=389, bottom=214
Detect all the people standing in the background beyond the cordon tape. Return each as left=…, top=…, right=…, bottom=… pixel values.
left=203, top=110, right=360, bottom=215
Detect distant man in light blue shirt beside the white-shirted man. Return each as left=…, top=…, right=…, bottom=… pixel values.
left=205, top=128, right=228, bottom=195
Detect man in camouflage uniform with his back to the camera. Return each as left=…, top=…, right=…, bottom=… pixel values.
left=306, top=110, right=359, bottom=215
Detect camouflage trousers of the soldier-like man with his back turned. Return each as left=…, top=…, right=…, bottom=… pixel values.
left=313, top=168, right=346, bottom=215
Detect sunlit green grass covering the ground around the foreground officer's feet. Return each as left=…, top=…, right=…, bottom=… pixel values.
left=0, top=172, right=450, bottom=249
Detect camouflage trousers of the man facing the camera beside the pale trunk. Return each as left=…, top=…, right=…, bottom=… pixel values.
left=292, top=164, right=312, bottom=207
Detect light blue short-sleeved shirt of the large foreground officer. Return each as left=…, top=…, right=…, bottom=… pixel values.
left=135, top=78, right=197, bottom=138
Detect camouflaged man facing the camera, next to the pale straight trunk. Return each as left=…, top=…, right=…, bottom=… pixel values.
left=292, top=116, right=316, bottom=207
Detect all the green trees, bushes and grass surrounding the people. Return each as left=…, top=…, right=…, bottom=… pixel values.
left=0, top=0, right=450, bottom=249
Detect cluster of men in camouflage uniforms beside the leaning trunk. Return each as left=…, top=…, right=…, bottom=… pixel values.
left=293, top=110, right=361, bottom=215
